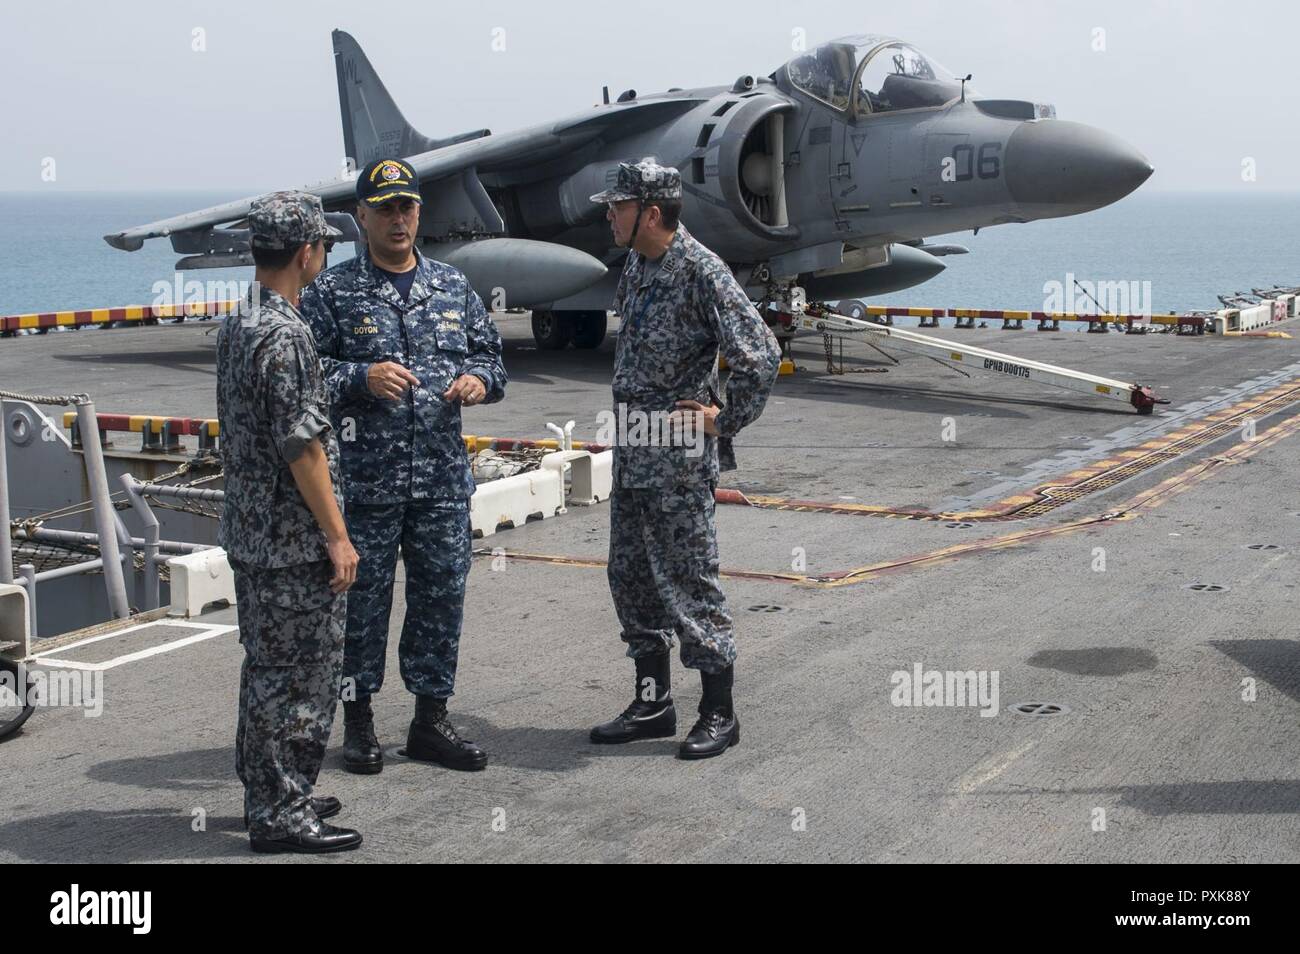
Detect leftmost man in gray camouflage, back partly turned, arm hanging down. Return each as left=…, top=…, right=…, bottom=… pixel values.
left=217, top=192, right=361, bottom=853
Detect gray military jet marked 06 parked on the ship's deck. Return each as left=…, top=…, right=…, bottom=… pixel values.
left=104, top=30, right=1152, bottom=348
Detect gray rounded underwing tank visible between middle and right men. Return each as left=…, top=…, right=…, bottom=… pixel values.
left=421, top=238, right=608, bottom=309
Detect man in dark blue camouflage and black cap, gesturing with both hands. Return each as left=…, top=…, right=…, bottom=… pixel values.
left=303, top=159, right=506, bottom=773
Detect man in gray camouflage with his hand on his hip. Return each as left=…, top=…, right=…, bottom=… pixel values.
left=592, top=159, right=780, bottom=759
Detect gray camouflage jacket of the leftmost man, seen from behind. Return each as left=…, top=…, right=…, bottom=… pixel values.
left=217, top=289, right=343, bottom=568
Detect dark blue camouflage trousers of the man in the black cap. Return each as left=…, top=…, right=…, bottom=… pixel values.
left=343, top=498, right=472, bottom=699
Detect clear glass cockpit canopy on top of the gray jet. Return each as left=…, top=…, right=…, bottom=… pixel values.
left=787, top=36, right=971, bottom=117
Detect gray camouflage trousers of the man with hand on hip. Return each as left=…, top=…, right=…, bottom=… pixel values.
left=608, top=483, right=736, bottom=672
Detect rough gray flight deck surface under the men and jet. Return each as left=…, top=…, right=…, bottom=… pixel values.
left=0, top=316, right=1300, bottom=862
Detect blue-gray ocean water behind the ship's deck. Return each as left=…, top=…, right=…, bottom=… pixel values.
left=0, top=190, right=1300, bottom=315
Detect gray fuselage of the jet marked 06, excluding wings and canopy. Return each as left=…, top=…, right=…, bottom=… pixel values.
left=484, top=52, right=1151, bottom=291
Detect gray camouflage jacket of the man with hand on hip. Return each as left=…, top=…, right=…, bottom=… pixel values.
left=614, top=225, right=780, bottom=487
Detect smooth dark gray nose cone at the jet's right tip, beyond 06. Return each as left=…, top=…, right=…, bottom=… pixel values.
left=1006, top=120, right=1154, bottom=218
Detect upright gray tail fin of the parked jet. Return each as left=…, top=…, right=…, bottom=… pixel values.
left=333, top=30, right=439, bottom=169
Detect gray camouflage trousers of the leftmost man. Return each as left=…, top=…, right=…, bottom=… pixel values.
left=230, top=560, right=347, bottom=838
